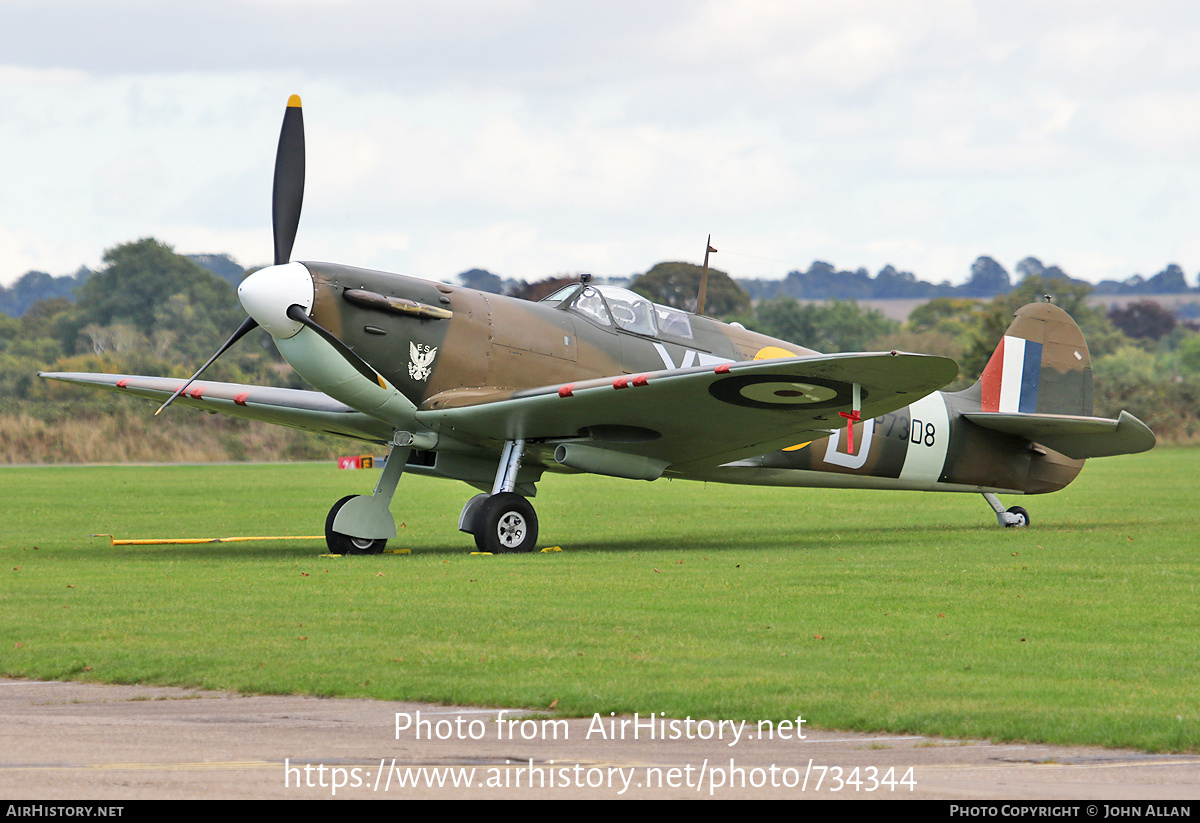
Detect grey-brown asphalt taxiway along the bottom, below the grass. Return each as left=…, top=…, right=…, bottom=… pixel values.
left=0, top=679, right=1200, bottom=801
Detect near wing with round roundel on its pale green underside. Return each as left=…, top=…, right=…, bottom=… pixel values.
left=416, top=353, right=958, bottom=476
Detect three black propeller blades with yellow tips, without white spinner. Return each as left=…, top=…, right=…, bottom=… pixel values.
left=155, top=95, right=372, bottom=414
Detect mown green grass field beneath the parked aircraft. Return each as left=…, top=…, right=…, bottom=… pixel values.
left=0, top=449, right=1200, bottom=751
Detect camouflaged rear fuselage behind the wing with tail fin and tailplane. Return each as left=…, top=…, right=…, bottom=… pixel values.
left=712, top=302, right=1118, bottom=494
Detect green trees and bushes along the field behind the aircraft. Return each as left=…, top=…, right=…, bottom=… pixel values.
left=0, top=239, right=1200, bottom=462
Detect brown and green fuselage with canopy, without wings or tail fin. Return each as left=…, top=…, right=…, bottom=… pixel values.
left=244, top=263, right=1082, bottom=493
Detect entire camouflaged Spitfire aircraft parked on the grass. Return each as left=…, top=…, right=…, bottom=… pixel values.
left=42, top=96, right=1154, bottom=554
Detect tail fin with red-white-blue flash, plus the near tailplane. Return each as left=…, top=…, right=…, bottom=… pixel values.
left=959, top=302, right=1154, bottom=459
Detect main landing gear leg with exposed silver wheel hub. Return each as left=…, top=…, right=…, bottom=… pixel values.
left=458, top=440, right=538, bottom=554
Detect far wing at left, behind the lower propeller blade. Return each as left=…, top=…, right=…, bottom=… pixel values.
left=37, top=372, right=391, bottom=443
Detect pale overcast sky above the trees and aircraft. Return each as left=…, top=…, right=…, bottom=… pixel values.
left=0, top=0, right=1200, bottom=290
